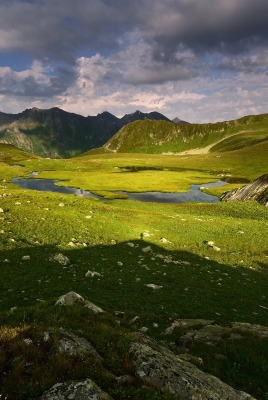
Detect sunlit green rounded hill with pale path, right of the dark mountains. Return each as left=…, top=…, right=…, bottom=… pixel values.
left=92, top=114, right=268, bottom=154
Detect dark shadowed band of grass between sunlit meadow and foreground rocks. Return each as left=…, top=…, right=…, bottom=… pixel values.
left=0, top=240, right=268, bottom=326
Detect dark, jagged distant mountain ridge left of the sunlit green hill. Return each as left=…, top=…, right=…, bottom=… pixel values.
left=0, top=107, right=180, bottom=158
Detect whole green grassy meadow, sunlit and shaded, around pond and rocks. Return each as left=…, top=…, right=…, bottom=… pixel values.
left=0, top=142, right=268, bottom=400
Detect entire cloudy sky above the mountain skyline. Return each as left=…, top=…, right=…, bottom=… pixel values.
left=0, top=0, right=268, bottom=123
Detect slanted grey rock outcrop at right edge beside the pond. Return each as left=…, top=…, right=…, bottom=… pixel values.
left=221, top=174, right=268, bottom=207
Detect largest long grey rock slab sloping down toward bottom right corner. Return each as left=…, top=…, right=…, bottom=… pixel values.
left=128, top=341, right=254, bottom=400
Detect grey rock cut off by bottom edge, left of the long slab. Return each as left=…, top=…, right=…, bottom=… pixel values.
left=39, top=379, right=112, bottom=400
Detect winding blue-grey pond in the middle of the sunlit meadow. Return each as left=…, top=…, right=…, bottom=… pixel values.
left=12, top=172, right=226, bottom=203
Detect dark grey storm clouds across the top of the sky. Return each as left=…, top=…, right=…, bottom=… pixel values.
left=0, top=0, right=268, bottom=93
